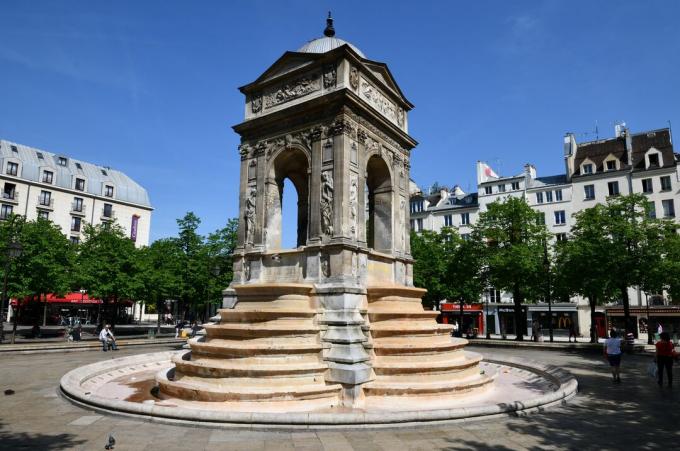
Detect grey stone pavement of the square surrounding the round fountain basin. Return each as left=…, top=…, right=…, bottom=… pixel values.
left=0, top=346, right=680, bottom=451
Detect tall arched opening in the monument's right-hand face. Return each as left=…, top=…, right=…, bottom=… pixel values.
left=366, top=155, right=392, bottom=253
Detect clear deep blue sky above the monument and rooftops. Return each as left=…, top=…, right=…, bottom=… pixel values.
left=0, top=0, right=680, bottom=244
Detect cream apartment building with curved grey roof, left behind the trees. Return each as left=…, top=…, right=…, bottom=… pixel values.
left=0, top=140, right=153, bottom=246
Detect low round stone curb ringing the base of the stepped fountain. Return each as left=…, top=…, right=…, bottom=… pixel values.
left=60, top=351, right=578, bottom=429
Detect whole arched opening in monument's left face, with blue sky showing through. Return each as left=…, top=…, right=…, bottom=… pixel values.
left=265, top=148, right=309, bottom=249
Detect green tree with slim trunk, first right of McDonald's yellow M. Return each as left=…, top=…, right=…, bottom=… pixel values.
left=554, top=205, right=619, bottom=343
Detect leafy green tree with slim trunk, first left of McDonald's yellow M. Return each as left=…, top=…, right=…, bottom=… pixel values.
left=474, top=197, right=548, bottom=341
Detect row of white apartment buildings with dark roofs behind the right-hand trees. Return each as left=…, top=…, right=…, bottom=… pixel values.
left=410, top=124, right=680, bottom=335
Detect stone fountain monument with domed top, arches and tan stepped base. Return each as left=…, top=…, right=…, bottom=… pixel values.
left=157, top=16, right=493, bottom=411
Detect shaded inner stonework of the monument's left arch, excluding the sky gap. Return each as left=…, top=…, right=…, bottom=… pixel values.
left=264, top=145, right=310, bottom=249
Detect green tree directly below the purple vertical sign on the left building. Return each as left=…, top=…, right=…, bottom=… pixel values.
left=76, top=222, right=140, bottom=324
